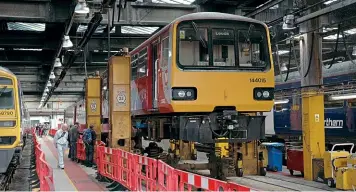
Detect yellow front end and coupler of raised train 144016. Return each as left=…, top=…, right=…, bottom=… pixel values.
left=170, top=15, right=275, bottom=143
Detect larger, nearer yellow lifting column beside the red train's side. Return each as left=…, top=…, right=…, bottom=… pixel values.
left=108, top=56, right=131, bottom=151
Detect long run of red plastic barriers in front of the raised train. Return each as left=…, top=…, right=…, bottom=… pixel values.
left=96, top=146, right=257, bottom=191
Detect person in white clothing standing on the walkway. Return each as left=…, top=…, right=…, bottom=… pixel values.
left=53, top=124, right=68, bottom=169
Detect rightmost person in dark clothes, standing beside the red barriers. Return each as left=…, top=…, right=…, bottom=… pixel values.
left=83, top=125, right=96, bottom=167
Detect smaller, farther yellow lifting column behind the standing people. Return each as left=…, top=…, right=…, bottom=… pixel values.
left=85, top=76, right=101, bottom=141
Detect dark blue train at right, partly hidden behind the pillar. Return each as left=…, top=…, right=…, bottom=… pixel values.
left=273, top=62, right=356, bottom=146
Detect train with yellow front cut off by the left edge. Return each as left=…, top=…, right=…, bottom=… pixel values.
left=0, top=67, right=31, bottom=189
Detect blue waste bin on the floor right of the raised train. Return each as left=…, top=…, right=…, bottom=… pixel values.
left=263, top=143, right=284, bottom=171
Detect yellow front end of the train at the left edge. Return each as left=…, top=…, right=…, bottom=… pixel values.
left=0, top=69, right=21, bottom=150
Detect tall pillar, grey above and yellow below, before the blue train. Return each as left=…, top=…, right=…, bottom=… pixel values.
left=299, top=0, right=325, bottom=180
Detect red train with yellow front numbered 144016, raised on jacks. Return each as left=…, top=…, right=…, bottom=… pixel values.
left=64, top=12, right=275, bottom=180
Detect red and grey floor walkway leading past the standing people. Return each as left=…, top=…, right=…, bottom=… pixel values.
left=38, top=137, right=107, bottom=191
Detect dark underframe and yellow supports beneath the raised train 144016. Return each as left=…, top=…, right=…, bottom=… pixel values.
left=133, top=110, right=267, bottom=179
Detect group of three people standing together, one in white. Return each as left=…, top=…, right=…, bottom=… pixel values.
left=53, top=123, right=96, bottom=169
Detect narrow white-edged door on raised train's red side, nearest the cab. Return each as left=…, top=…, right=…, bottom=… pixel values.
left=151, top=40, right=159, bottom=109
